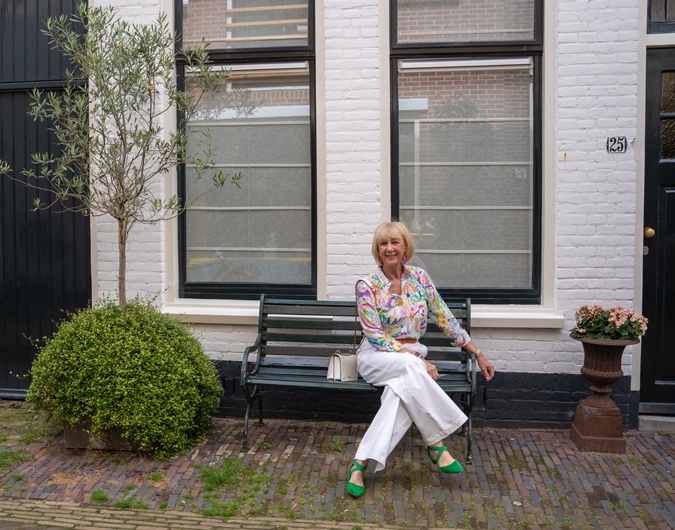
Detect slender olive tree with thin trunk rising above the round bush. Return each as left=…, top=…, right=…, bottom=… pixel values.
left=0, top=3, right=241, bottom=305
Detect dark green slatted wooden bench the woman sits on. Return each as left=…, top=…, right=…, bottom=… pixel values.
left=241, top=295, right=476, bottom=463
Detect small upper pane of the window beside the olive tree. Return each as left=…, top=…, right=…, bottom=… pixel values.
left=183, top=0, right=309, bottom=49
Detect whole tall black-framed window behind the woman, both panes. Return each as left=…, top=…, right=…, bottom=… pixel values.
left=391, top=0, right=543, bottom=303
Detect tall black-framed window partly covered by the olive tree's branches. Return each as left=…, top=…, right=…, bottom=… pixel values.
left=180, top=0, right=316, bottom=298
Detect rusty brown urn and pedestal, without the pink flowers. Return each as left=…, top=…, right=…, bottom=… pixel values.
left=570, top=334, right=640, bottom=453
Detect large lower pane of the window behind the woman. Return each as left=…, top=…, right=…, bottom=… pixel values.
left=398, top=59, right=533, bottom=288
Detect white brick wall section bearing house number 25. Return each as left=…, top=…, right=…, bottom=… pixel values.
left=556, top=0, right=638, bottom=373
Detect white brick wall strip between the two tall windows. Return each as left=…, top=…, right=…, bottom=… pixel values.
left=318, top=0, right=388, bottom=299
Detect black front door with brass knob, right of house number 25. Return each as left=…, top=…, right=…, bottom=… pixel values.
left=640, top=49, right=675, bottom=414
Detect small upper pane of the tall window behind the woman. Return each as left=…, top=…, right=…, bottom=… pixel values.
left=397, top=0, right=534, bottom=43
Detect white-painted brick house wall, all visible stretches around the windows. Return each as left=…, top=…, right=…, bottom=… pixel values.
left=95, top=0, right=638, bottom=375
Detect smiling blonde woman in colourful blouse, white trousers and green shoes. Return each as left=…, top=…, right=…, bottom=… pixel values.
left=347, top=222, right=494, bottom=497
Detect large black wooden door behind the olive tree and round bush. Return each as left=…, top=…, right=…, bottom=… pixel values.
left=0, top=0, right=91, bottom=398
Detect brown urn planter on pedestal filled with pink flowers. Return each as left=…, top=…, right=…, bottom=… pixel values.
left=570, top=305, right=647, bottom=453
